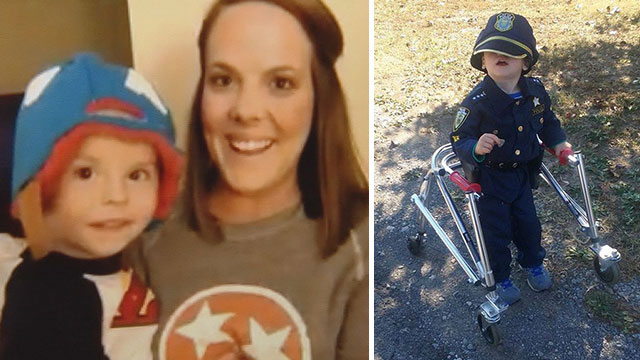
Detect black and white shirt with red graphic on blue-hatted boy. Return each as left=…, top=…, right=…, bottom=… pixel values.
left=0, top=234, right=157, bottom=360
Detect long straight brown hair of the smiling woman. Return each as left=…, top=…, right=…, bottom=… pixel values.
left=183, top=0, right=369, bottom=256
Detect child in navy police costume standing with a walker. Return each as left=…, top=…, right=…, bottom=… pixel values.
left=450, top=12, right=571, bottom=304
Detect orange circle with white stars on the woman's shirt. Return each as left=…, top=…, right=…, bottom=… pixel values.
left=160, top=285, right=310, bottom=360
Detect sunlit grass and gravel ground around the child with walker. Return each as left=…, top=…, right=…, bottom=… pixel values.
left=373, top=0, right=640, bottom=359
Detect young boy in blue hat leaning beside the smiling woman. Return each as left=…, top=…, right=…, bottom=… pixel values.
left=0, top=54, right=181, bottom=360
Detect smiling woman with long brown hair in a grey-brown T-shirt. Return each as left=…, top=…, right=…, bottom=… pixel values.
left=138, top=0, right=368, bottom=359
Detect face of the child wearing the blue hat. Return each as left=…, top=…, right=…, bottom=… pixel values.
left=44, top=135, right=158, bottom=258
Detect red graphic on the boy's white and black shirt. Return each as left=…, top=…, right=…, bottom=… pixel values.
left=111, top=273, right=158, bottom=328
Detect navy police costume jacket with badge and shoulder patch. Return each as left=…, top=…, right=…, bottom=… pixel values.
left=450, top=75, right=566, bottom=203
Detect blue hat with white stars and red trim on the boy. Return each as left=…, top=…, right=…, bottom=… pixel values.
left=11, top=53, right=182, bottom=218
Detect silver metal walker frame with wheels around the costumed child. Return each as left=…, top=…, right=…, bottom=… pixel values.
left=408, top=144, right=621, bottom=345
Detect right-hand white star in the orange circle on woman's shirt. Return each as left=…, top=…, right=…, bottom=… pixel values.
left=242, top=318, right=291, bottom=360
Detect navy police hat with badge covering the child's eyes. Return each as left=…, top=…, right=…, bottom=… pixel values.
left=471, top=12, right=538, bottom=74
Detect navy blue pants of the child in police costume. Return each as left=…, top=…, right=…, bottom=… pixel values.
left=478, top=181, right=546, bottom=283
